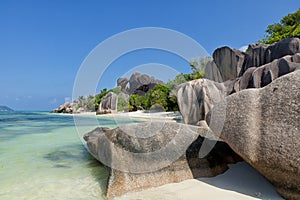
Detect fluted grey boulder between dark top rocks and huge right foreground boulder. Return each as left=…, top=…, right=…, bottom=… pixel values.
left=233, top=53, right=300, bottom=92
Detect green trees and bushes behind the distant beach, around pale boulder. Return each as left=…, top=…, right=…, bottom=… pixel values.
left=72, top=57, right=211, bottom=111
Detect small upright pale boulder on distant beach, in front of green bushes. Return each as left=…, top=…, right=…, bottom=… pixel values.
left=97, top=92, right=118, bottom=114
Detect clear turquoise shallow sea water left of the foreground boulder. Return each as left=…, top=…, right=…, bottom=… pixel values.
left=0, top=112, right=141, bottom=200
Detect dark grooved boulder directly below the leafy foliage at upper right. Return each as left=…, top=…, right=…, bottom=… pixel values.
left=240, top=37, right=300, bottom=75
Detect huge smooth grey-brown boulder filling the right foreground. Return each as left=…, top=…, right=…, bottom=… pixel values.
left=207, top=70, right=300, bottom=199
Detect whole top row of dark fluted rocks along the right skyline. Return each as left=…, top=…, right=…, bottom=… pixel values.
left=205, top=37, right=300, bottom=82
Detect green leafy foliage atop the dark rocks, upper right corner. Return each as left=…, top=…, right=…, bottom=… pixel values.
left=260, top=9, right=300, bottom=44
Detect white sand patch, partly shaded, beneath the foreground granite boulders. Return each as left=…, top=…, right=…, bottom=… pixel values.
left=115, top=162, right=283, bottom=200
